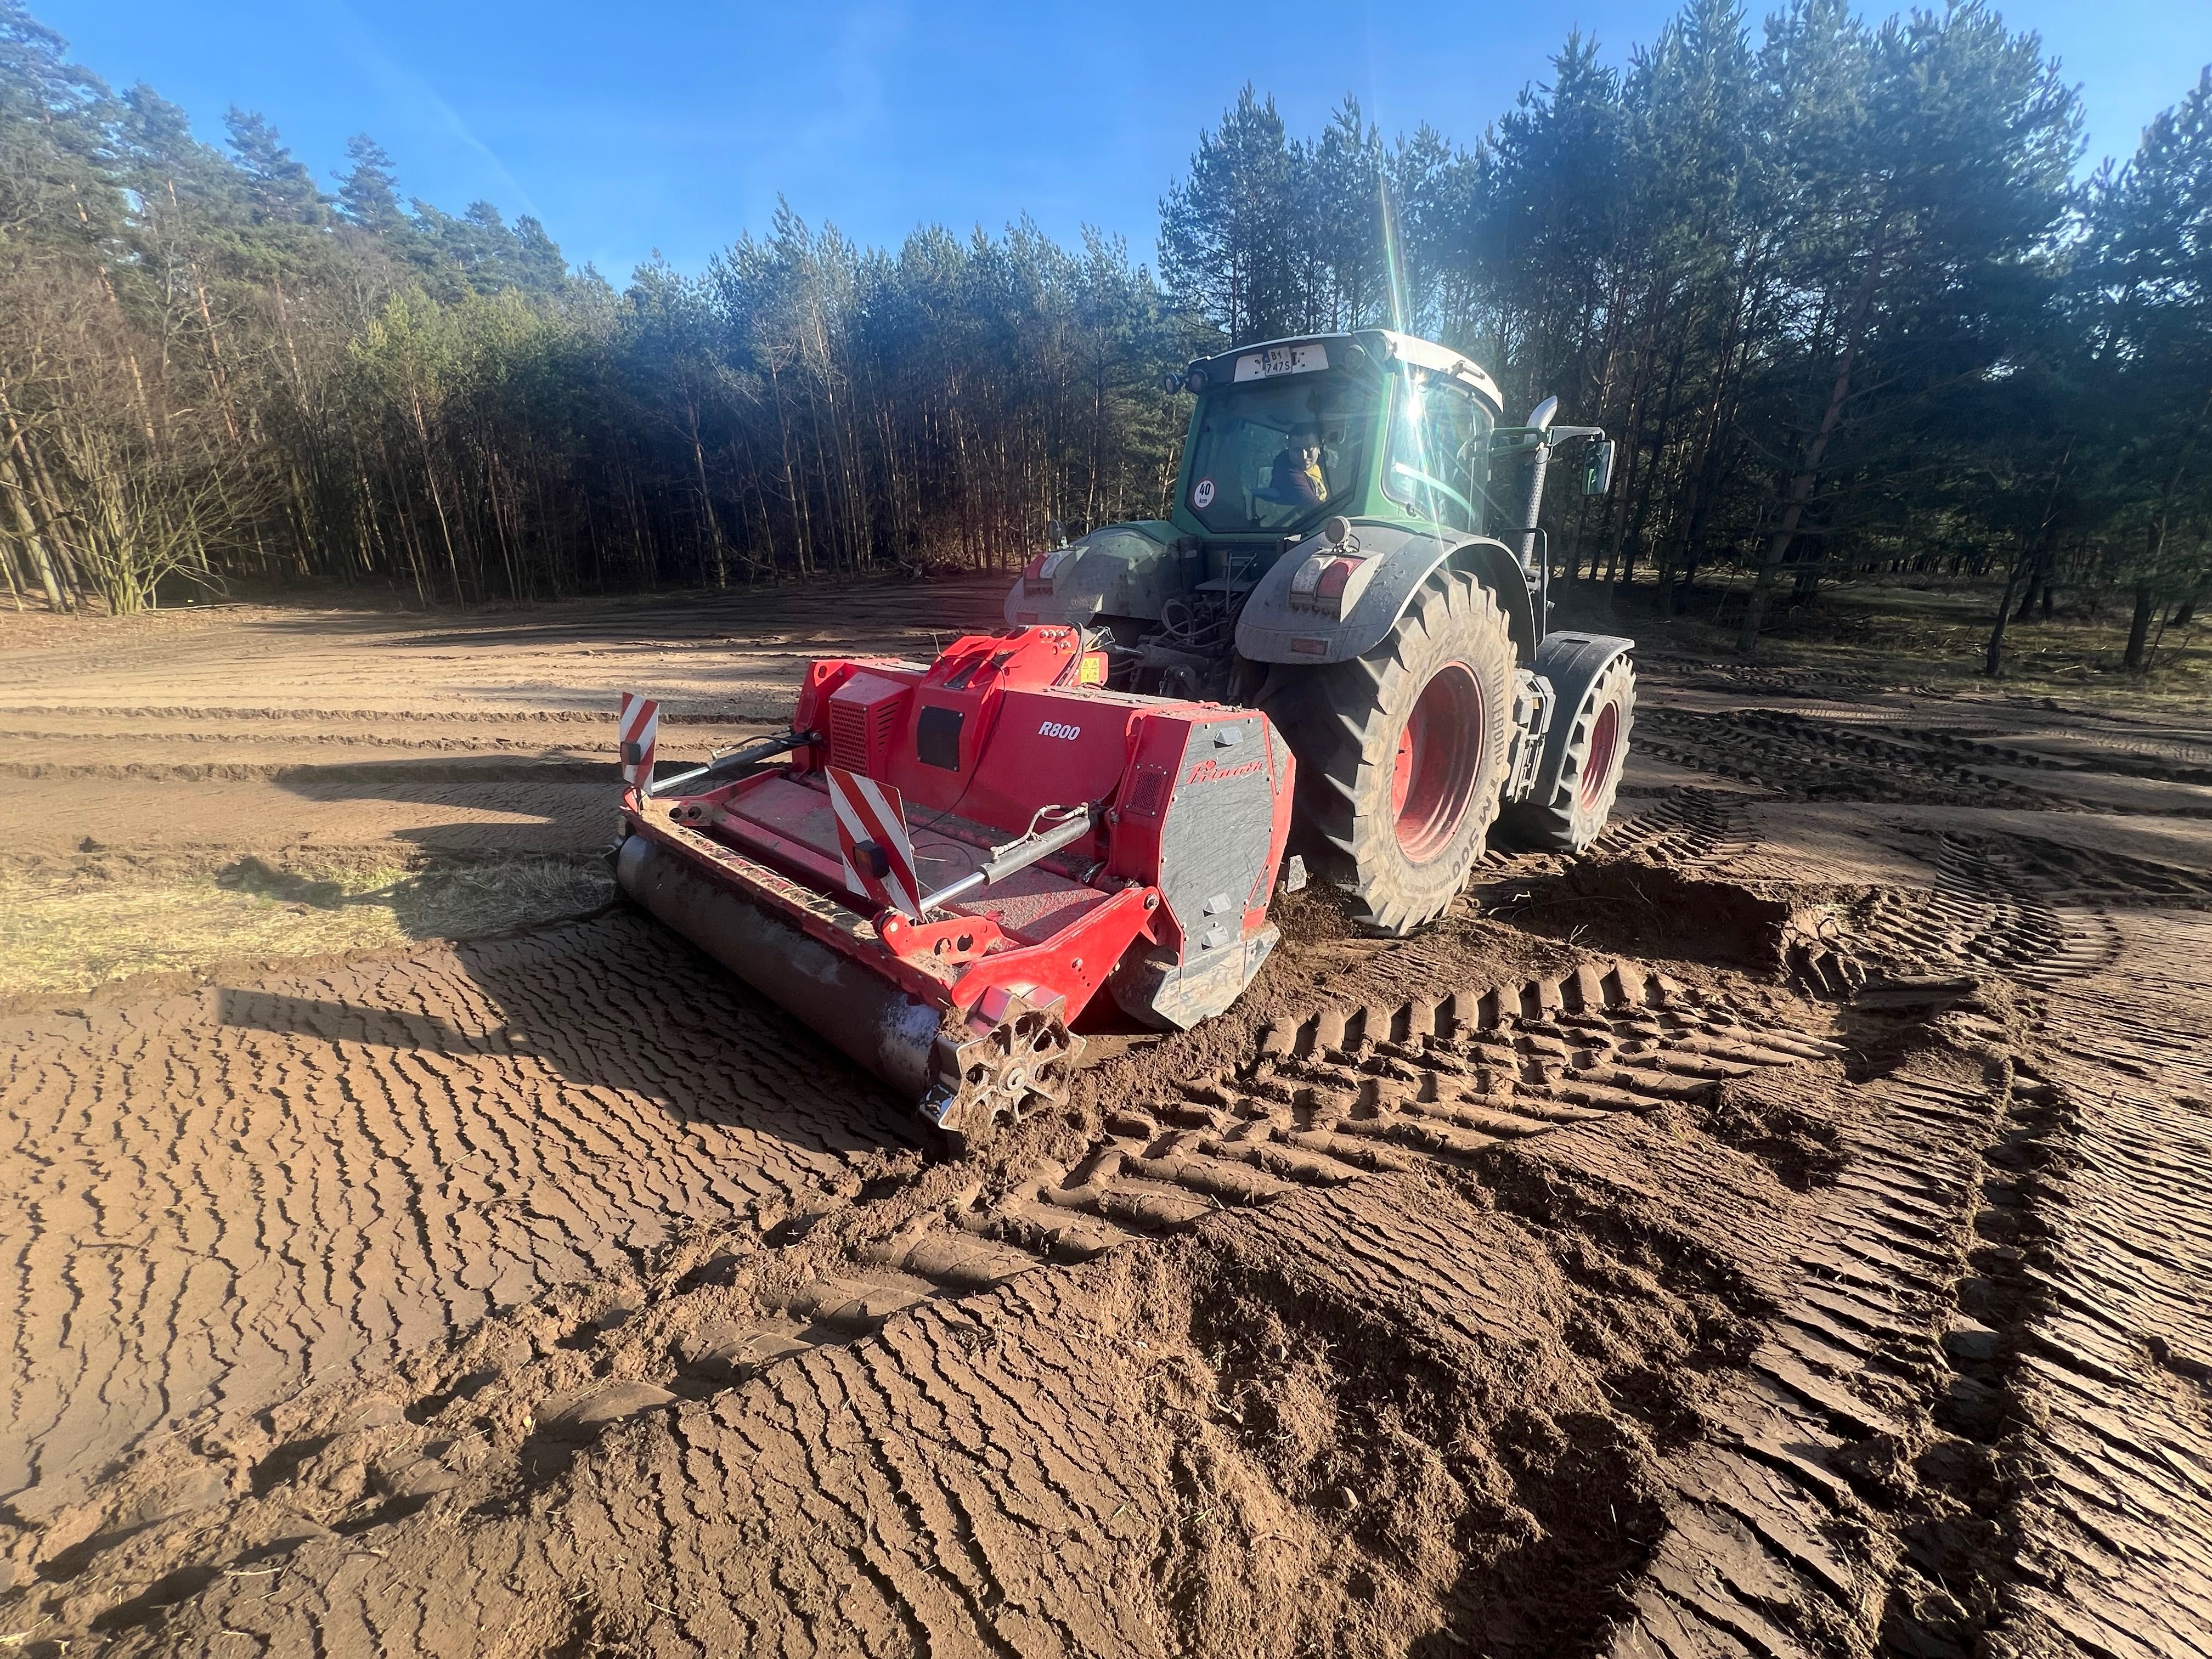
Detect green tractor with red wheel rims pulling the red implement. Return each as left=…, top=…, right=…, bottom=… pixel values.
left=1007, top=330, right=1637, bottom=936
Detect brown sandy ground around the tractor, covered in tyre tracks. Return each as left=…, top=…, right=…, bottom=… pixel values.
left=0, top=586, right=2212, bottom=1659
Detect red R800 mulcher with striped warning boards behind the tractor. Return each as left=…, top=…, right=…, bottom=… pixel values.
left=615, top=626, right=1294, bottom=1150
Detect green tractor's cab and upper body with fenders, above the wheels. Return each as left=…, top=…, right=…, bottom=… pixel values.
left=1007, top=328, right=1612, bottom=699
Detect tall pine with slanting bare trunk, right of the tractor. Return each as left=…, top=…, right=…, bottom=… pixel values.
left=1736, top=0, right=2081, bottom=654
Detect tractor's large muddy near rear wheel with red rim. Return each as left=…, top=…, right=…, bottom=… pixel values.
left=1259, top=571, right=1513, bottom=938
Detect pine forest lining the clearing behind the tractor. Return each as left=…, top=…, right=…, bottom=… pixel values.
left=0, top=0, right=2212, bottom=668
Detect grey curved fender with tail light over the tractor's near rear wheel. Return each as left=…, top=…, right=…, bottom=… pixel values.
left=1237, top=520, right=1535, bottom=668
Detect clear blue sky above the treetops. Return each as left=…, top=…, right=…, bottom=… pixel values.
left=31, top=0, right=2212, bottom=281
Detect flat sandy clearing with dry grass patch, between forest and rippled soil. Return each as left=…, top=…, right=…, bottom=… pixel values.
left=0, top=584, right=997, bottom=1002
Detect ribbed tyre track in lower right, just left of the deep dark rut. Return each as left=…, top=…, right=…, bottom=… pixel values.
left=1610, top=1077, right=1991, bottom=1657
